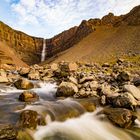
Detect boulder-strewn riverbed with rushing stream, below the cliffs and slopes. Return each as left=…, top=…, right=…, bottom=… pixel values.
left=0, top=59, right=140, bottom=140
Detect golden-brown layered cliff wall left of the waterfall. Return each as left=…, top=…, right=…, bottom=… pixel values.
left=0, top=22, right=43, bottom=65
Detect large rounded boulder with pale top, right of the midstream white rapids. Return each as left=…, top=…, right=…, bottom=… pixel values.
left=56, top=82, right=78, bottom=97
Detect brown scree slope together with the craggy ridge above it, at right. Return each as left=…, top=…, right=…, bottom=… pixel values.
left=42, top=6, right=140, bottom=62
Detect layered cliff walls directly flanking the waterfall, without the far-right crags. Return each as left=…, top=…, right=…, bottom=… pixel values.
left=0, top=21, right=94, bottom=65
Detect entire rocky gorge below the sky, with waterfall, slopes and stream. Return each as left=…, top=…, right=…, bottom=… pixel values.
left=0, top=3, right=140, bottom=140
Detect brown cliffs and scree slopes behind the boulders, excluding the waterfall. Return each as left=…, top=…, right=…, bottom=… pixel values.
left=0, top=6, right=140, bottom=65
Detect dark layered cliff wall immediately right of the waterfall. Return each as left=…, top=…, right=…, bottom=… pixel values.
left=46, top=21, right=94, bottom=59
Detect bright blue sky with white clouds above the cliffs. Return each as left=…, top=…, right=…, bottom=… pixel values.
left=0, top=0, right=140, bottom=38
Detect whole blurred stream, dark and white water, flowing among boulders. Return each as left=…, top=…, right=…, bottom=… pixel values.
left=0, top=82, right=140, bottom=140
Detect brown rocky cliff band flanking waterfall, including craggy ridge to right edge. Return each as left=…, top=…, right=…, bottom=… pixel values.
left=0, top=6, right=140, bottom=65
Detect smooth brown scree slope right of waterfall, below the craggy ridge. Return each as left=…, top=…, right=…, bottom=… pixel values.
left=44, top=26, right=140, bottom=62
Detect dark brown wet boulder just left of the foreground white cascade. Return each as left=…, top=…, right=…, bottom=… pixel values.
left=18, top=110, right=46, bottom=129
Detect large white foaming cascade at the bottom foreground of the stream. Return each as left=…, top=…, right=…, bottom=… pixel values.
left=34, top=109, right=132, bottom=140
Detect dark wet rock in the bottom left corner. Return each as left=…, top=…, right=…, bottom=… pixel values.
left=0, top=124, right=17, bottom=140
